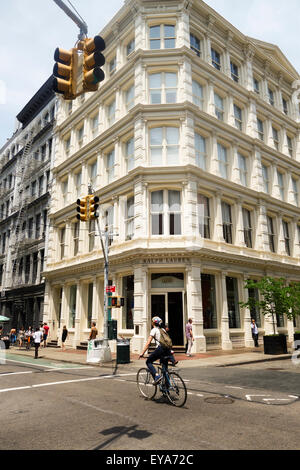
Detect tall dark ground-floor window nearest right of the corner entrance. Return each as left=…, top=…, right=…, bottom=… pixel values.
left=201, top=274, right=218, bottom=329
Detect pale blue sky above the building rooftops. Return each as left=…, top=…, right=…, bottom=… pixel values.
left=0, top=0, right=300, bottom=148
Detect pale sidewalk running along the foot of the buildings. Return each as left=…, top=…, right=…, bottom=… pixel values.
left=7, top=346, right=292, bottom=368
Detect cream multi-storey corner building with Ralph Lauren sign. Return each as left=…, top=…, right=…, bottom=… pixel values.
left=44, top=0, right=300, bottom=352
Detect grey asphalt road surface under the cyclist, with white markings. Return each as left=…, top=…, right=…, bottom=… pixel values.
left=0, top=357, right=300, bottom=451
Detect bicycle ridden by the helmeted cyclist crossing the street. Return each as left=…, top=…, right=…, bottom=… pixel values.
left=136, top=358, right=187, bottom=407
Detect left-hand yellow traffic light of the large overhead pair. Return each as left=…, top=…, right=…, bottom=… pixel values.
left=53, top=47, right=78, bottom=100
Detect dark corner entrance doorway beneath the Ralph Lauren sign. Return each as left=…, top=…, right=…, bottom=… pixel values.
left=151, top=292, right=184, bottom=346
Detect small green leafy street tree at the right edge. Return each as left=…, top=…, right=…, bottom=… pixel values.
left=240, top=277, right=294, bottom=335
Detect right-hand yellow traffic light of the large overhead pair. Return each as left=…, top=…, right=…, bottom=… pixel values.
left=82, top=36, right=105, bottom=91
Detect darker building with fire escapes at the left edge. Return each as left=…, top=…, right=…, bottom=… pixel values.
left=0, top=79, right=56, bottom=329
